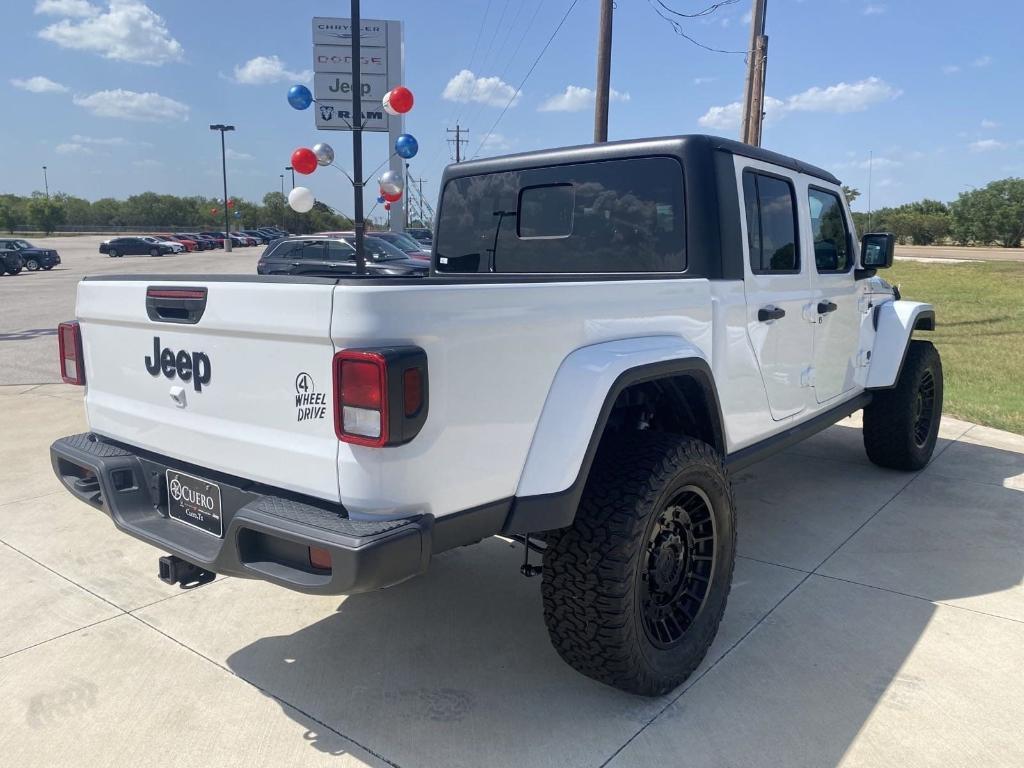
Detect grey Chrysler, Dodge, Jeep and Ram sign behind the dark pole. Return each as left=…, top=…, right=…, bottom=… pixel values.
left=312, top=16, right=402, bottom=131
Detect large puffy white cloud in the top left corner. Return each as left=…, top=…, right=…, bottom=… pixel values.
left=39, top=0, right=184, bottom=67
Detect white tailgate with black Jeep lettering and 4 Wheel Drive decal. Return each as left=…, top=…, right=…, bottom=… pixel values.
left=77, top=278, right=338, bottom=501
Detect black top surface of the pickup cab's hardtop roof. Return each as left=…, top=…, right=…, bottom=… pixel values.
left=444, top=133, right=840, bottom=184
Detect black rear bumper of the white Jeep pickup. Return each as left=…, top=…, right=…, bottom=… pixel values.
left=50, top=434, right=434, bottom=595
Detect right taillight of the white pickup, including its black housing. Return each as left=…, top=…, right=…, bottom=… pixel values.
left=334, top=346, right=428, bottom=447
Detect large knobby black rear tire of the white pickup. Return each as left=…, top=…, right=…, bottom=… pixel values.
left=542, top=433, right=736, bottom=696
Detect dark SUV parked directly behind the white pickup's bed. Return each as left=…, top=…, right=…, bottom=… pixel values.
left=256, top=232, right=429, bottom=278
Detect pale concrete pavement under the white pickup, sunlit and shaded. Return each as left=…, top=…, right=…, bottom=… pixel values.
left=0, top=385, right=1024, bottom=768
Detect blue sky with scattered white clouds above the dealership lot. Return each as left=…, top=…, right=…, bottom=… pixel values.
left=0, top=0, right=1024, bottom=219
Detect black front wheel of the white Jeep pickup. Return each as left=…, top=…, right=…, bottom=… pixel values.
left=864, top=339, right=942, bottom=471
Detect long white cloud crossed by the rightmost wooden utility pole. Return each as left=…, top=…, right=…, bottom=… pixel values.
left=697, top=77, right=902, bottom=130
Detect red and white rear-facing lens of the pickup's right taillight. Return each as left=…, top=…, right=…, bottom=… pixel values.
left=334, top=350, right=388, bottom=447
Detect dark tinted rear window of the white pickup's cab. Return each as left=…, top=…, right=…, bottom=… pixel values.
left=435, top=158, right=686, bottom=273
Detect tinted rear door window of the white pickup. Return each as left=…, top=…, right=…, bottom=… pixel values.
left=743, top=171, right=800, bottom=273
